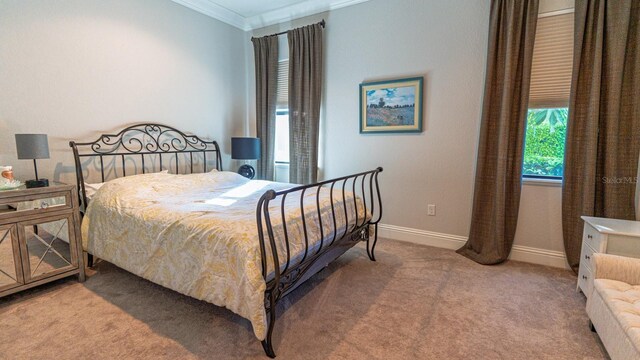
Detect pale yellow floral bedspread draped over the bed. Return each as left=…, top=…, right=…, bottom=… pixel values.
left=82, top=170, right=369, bottom=340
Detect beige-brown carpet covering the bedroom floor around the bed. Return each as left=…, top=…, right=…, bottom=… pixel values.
left=0, top=239, right=606, bottom=359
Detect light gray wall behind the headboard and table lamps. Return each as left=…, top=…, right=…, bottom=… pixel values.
left=0, top=0, right=246, bottom=182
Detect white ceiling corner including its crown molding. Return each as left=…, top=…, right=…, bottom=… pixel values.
left=173, top=0, right=368, bottom=31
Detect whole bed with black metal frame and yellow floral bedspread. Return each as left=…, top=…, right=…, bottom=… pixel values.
left=69, top=124, right=382, bottom=357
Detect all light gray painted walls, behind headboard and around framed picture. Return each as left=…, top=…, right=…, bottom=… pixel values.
left=0, top=0, right=572, bottom=262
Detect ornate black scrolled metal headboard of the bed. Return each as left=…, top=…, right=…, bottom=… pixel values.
left=69, top=124, right=222, bottom=209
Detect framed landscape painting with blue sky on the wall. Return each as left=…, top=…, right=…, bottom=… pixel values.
left=360, top=76, right=423, bottom=134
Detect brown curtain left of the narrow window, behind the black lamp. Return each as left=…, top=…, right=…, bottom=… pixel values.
left=251, top=36, right=278, bottom=180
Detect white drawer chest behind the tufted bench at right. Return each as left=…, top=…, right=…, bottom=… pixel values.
left=577, top=216, right=640, bottom=297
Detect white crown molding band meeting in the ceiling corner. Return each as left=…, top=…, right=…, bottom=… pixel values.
left=172, top=0, right=369, bottom=31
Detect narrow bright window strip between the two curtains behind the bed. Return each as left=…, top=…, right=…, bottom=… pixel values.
left=274, top=60, right=289, bottom=164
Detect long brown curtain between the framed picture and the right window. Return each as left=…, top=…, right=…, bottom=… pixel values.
left=458, top=0, right=539, bottom=264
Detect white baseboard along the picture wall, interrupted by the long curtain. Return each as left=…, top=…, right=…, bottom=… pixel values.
left=378, top=224, right=569, bottom=269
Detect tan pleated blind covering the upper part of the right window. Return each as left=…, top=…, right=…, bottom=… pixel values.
left=529, top=13, right=573, bottom=109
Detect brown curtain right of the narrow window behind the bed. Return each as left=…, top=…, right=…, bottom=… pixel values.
left=287, top=24, right=322, bottom=184
